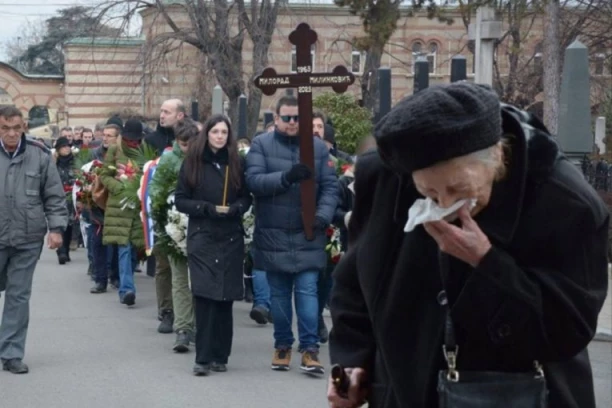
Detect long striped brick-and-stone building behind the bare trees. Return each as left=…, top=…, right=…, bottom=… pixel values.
left=0, top=3, right=612, bottom=126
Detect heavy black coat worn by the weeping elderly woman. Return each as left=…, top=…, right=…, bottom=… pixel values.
left=330, top=107, right=609, bottom=408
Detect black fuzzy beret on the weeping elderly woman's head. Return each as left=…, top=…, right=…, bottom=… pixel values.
left=374, top=82, right=502, bottom=173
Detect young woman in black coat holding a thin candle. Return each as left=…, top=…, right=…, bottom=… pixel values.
left=175, top=115, right=251, bottom=375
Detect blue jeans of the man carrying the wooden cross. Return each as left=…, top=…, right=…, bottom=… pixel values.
left=267, top=271, right=319, bottom=352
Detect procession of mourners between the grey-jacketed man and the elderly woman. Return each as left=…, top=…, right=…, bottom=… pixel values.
left=43, top=96, right=360, bottom=374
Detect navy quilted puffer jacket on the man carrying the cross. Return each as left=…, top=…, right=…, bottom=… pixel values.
left=246, top=131, right=338, bottom=273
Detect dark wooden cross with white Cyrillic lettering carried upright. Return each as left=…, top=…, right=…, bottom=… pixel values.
left=255, top=23, right=355, bottom=240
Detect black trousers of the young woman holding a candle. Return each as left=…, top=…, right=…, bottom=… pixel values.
left=193, top=296, right=234, bottom=364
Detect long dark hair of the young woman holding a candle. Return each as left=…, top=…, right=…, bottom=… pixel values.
left=185, top=114, right=243, bottom=190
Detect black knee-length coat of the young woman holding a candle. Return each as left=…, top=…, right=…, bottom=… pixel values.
left=175, top=148, right=251, bottom=301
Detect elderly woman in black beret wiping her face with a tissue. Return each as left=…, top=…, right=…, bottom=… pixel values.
left=328, top=83, right=609, bottom=408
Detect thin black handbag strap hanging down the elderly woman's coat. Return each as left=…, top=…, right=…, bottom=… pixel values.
left=438, top=250, right=544, bottom=382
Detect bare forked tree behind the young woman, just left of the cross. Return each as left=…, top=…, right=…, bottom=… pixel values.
left=99, top=0, right=284, bottom=134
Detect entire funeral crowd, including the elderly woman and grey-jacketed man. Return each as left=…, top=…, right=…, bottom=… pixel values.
left=0, top=81, right=609, bottom=408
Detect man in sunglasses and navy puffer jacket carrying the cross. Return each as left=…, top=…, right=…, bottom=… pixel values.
left=246, top=96, right=338, bottom=374
